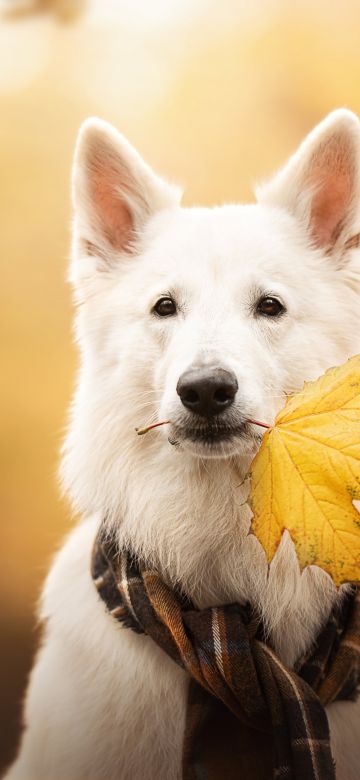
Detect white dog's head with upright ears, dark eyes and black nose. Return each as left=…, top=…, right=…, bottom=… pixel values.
left=64, top=110, right=360, bottom=508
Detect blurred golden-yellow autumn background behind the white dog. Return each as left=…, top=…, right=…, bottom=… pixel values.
left=0, top=0, right=360, bottom=768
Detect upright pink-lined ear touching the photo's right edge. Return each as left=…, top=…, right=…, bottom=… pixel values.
left=257, top=109, right=360, bottom=253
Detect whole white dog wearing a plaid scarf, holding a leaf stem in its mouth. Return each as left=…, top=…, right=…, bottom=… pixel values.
left=6, top=110, right=360, bottom=780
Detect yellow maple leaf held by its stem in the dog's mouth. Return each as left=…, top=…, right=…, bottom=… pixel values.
left=250, top=355, right=360, bottom=585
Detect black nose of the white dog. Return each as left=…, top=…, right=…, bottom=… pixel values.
left=176, top=368, right=238, bottom=417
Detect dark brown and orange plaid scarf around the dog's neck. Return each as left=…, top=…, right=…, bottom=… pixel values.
left=92, top=536, right=360, bottom=780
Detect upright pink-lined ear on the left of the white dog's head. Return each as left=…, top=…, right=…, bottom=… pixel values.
left=73, top=118, right=180, bottom=269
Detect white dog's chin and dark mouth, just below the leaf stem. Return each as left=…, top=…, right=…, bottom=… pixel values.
left=168, top=421, right=261, bottom=458
